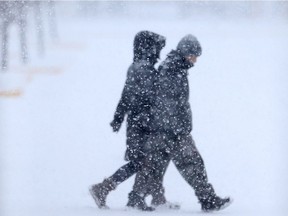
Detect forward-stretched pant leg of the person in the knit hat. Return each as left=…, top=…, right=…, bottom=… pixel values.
left=171, top=135, right=215, bottom=200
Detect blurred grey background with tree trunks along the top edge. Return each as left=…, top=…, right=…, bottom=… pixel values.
left=0, top=0, right=288, bottom=74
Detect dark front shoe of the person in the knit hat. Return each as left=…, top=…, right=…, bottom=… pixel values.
left=200, top=196, right=232, bottom=212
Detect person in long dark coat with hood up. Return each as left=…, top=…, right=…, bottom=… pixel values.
left=89, top=31, right=177, bottom=211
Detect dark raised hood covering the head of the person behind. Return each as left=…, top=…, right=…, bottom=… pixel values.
left=133, top=31, right=166, bottom=64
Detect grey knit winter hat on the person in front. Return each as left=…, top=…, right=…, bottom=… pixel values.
left=177, top=34, right=202, bottom=56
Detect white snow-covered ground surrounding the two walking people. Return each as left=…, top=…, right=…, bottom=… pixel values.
left=0, top=2, right=288, bottom=216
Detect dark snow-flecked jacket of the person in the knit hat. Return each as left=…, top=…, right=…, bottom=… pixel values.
left=153, top=51, right=193, bottom=135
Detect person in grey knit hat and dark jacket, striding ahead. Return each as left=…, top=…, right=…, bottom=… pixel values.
left=128, top=34, right=231, bottom=211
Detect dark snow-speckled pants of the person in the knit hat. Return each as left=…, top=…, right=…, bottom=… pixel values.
left=133, top=134, right=215, bottom=200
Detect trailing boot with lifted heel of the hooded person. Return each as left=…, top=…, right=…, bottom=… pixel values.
left=89, top=178, right=116, bottom=208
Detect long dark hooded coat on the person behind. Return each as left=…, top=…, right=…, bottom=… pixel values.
left=112, top=31, right=165, bottom=160
